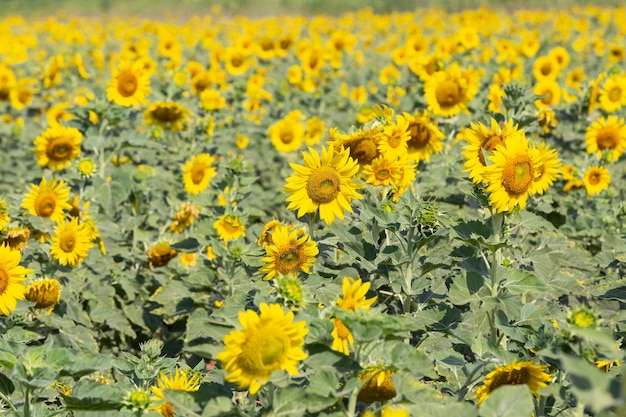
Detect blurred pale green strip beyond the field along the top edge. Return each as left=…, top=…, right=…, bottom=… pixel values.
left=0, top=0, right=623, bottom=16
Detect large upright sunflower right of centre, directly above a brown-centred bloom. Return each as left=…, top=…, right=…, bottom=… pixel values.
left=424, top=64, right=472, bottom=117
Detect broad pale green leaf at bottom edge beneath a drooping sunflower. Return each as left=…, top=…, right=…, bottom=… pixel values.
left=479, top=384, right=534, bottom=417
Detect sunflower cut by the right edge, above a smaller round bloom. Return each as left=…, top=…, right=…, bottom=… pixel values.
left=585, top=116, right=626, bottom=162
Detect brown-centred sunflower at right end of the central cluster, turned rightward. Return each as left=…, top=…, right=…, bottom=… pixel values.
left=398, top=110, right=445, bottom=162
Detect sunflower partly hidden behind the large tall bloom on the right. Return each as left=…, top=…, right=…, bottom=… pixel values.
left=463, top=118, right=524, bottom=184
